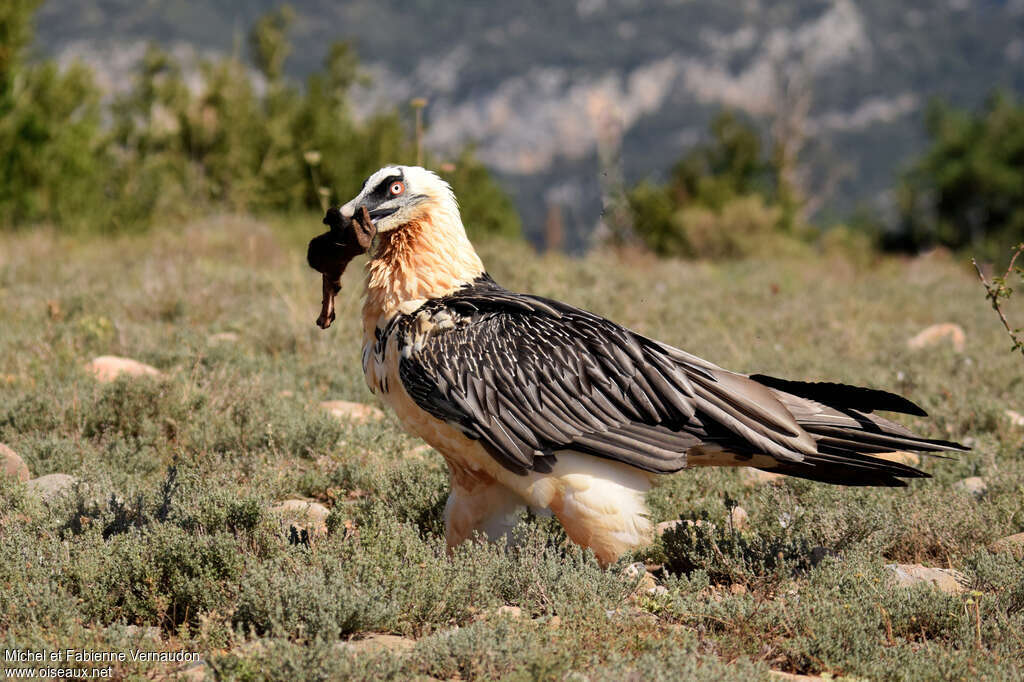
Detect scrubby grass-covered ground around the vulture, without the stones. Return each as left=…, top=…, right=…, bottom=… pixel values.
left=0, top=218, right=1024, bottom=680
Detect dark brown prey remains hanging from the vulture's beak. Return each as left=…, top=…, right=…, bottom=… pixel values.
left=306, top=202, right=377, bottom=329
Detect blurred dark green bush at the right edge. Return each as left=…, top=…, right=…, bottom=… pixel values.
left=884, top=92, right=1024, bottom=255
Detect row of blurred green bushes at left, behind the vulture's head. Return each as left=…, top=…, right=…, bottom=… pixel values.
left=0, top=0, right=520, bottom=237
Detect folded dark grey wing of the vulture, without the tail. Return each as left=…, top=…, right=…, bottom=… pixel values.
left=396, top=282, right=816, bottom=473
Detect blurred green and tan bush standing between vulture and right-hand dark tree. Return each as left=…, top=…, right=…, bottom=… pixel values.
left=629, top=111, right=798, bottom=258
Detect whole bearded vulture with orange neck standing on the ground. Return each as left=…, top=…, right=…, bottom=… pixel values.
left=321, top=166, right=967, bottom=564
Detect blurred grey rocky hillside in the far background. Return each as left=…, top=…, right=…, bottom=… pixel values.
left=38, top=0, right=1024, bottom=244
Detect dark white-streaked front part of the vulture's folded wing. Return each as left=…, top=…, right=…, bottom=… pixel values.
left=396, top=278, right=697, bottom=472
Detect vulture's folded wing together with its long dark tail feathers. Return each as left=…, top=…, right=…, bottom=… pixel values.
left=393, top=275, right=965, bottom=485
